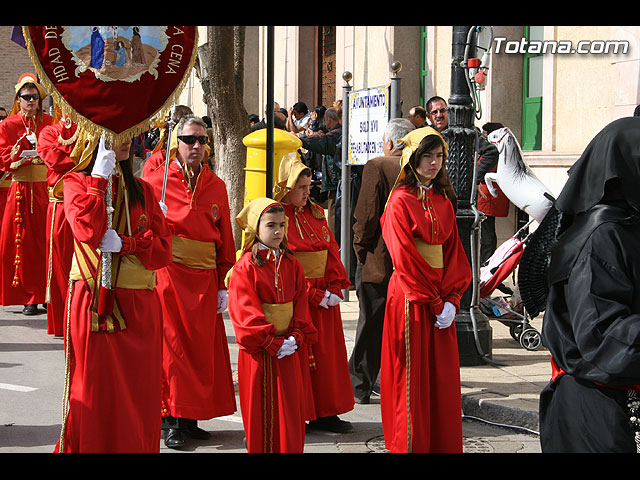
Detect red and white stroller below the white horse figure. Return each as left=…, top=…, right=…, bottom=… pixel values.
left=478, top=220, right=541, bottom=350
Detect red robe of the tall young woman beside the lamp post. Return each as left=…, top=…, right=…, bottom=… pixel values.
left=380, top=187, right=471, bottom=453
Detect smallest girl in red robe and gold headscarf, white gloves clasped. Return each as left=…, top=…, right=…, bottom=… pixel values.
left=229, top=198, right=317, bottom=453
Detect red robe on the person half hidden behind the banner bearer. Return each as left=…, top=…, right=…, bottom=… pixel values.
left=38, top=122, right=77, bottom=336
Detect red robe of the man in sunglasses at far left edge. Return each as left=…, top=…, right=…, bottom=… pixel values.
left=0, top=113, right=52, bottom=305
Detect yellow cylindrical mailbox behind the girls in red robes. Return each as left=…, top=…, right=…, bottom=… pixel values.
left=242, top=128, right=302, bottom=206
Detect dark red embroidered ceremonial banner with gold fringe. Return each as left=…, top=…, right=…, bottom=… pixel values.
left=22, top=26, right=198, bottom=142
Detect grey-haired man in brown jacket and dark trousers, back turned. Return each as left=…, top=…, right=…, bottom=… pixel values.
left=349, top=118, right=415, bottom=403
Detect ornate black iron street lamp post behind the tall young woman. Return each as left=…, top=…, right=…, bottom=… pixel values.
left=442, top=26, right=492, bottom=366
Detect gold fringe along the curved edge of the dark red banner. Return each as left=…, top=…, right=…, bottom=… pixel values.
left=22, top=26, right=198, bottom=145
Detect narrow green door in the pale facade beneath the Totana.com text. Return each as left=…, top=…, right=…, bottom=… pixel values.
left=522, top=26, right=544, bottom=150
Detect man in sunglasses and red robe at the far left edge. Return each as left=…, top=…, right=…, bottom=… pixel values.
left=0, top=73, right=52, bottom=315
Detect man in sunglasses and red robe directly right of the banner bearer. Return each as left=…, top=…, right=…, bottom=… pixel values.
left=143, top=116, right=236, bottom=448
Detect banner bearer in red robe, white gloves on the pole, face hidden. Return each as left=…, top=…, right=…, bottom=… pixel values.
left=55, top=135, right=171, bottom=453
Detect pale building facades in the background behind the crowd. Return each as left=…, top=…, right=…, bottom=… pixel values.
left=5, top=25, right=640, bottom=242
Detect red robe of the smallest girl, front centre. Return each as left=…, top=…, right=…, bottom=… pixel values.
left=229, top=250, right=317, bottom=453
